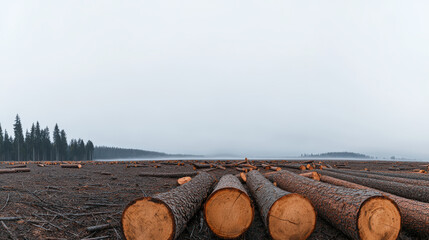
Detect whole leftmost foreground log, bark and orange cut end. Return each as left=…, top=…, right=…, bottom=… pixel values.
left=121, top=172, right=216, bottom=240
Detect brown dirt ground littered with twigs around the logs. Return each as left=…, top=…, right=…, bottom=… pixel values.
left=0, top=160, right=427, bottom=240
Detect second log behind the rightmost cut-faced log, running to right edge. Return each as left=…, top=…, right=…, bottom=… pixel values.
left=317, top=170, right=429, bottom=202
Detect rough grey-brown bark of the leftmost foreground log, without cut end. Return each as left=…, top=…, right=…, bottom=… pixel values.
left=122, top=172, right=216, bottom=239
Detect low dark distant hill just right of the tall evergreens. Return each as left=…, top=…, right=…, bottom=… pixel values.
left=94, top=146, right=193, bottom=159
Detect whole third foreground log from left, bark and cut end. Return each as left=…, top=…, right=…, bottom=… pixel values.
left=247, top=171, right=316, bottom=239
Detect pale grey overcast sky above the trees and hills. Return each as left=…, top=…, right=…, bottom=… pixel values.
left=0, top=0, right=429, bottom=159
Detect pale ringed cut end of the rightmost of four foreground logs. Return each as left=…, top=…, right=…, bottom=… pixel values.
left=357, top=197, right=401, bottom=240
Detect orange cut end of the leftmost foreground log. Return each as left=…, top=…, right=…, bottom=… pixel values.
left=122, top=197, right=175, bottom=240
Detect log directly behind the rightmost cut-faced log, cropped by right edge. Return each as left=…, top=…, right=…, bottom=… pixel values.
left=320, top=175, right=429, bottom=239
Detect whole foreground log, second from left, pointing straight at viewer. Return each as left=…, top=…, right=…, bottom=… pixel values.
left=204, top=174, right=254, bottom=239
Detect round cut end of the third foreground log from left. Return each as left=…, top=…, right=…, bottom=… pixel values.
left=267, top=193, right=316, bottom=240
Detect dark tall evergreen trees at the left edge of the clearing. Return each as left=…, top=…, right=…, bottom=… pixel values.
left=0, top=115, right=94, bottom=161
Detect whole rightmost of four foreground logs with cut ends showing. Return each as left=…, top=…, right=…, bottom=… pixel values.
left=270, top=171, right=401, bottom=240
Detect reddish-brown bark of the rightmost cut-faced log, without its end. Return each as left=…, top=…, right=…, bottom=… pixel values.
left=269, top=171, right=399, bottom=239
